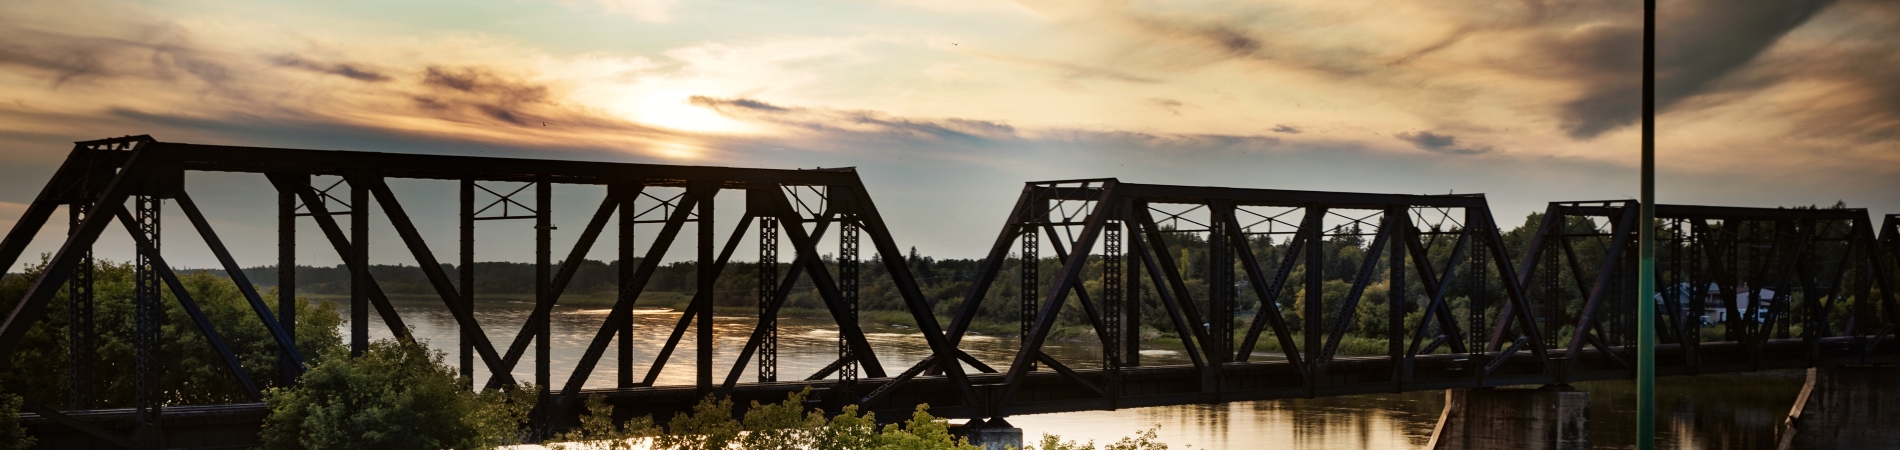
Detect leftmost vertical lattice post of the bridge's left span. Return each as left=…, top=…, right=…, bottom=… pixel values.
left=67, top=201, right=95, bottom=410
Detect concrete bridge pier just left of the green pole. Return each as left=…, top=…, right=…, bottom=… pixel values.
left=1427, top=385, right=1590, bottom=450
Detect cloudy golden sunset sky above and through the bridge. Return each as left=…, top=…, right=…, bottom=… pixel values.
left=0, top=0, right=1900, bottom=266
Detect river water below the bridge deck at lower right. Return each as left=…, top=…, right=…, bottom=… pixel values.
left=1009, top=370, right=1805, bottom=450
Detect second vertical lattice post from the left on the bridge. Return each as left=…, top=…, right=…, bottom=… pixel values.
left=133, top=196, right=165, bottom=435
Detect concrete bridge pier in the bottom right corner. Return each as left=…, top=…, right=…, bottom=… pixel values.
left=1780, top=366, right=1900, bottom=450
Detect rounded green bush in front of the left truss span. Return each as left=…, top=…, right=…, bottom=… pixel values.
left=262, top=340, right=534, bottom=448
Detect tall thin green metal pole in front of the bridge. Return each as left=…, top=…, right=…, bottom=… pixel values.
left=1636, top=0, right=1657, bottom=450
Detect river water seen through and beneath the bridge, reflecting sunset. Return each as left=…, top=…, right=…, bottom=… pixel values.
left=344, top=300, right=1805, bottom=450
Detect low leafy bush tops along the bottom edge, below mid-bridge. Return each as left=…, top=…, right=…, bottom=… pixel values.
left=549, top=387, right=1169, bottom=450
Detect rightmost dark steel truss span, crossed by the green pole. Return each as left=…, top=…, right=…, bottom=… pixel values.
left=1492, top=201, right=1900, bottom=372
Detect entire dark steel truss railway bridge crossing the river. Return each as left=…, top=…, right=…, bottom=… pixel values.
left=11, top=137, right=1900, bottom=448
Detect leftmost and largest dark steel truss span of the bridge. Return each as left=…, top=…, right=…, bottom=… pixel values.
left=0, top=137, right=969, bottom=446
